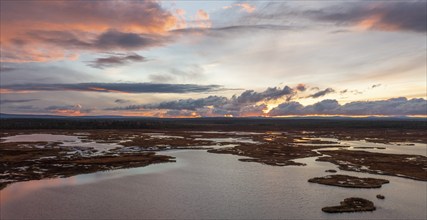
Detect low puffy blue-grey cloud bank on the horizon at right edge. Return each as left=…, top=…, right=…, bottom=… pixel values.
left=269, top=97, right=427, bottom=116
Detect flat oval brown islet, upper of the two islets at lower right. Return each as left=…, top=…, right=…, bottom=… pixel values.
left=308, top=175, right=390, bottom=188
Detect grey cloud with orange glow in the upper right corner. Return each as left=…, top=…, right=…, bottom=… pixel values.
left=245, top=0, right=427, bottom=33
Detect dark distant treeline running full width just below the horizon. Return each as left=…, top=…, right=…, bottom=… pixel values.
left=0, top=118, right=427, bottom=131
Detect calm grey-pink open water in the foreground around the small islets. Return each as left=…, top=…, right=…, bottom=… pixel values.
left=0, top=150, right=427, bottom=219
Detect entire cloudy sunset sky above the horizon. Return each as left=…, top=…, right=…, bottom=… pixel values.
left=0, top=0, right=427, bottom=117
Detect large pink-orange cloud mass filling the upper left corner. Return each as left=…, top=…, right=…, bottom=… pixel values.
left=0, top=0, right=177, bottom=62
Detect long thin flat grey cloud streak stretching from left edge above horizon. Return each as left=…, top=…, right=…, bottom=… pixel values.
left=2, top=83, right=223, bottom=93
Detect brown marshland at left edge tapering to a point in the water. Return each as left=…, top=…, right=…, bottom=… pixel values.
left=0, top=139, right=175, bottom=189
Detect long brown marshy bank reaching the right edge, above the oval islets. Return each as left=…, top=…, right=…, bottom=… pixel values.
left=317, top=150, right=427, bottom=181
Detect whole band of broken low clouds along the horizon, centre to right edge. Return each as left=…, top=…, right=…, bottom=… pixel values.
left=105, top=85, right=427, bottom=117
